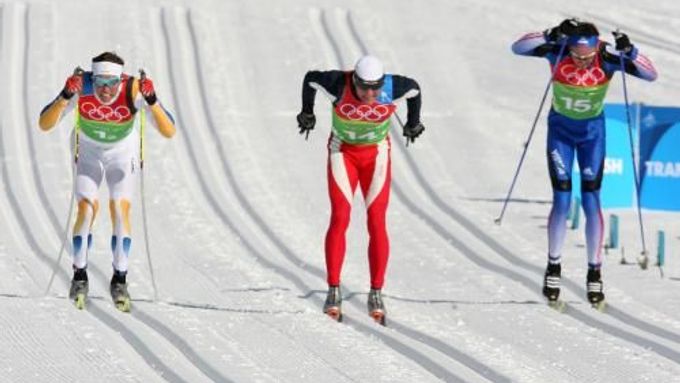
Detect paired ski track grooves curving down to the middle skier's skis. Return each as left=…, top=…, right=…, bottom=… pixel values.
left=162, top=5, right=484, bottom=381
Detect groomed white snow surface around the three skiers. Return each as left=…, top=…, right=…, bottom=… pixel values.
left=0, top=0, right=680, bottom=382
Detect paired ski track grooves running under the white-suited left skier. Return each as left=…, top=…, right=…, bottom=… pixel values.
left=11, top=3, right=229, bottom=382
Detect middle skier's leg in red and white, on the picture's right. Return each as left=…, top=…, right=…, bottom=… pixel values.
left=359, top=140, right=392, bottom=290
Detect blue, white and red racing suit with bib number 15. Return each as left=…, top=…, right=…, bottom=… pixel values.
left=512, top=32, right=657, bottom=269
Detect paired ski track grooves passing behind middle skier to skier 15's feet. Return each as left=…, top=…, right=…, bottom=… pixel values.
left=348, top=12, right=680, bottom=364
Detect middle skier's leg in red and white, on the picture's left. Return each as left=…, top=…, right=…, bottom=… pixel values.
left=325, top=139, right=358, bottom=286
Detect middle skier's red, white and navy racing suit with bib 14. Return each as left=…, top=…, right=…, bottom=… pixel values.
left=302, top=70, right=420, bottom=289
